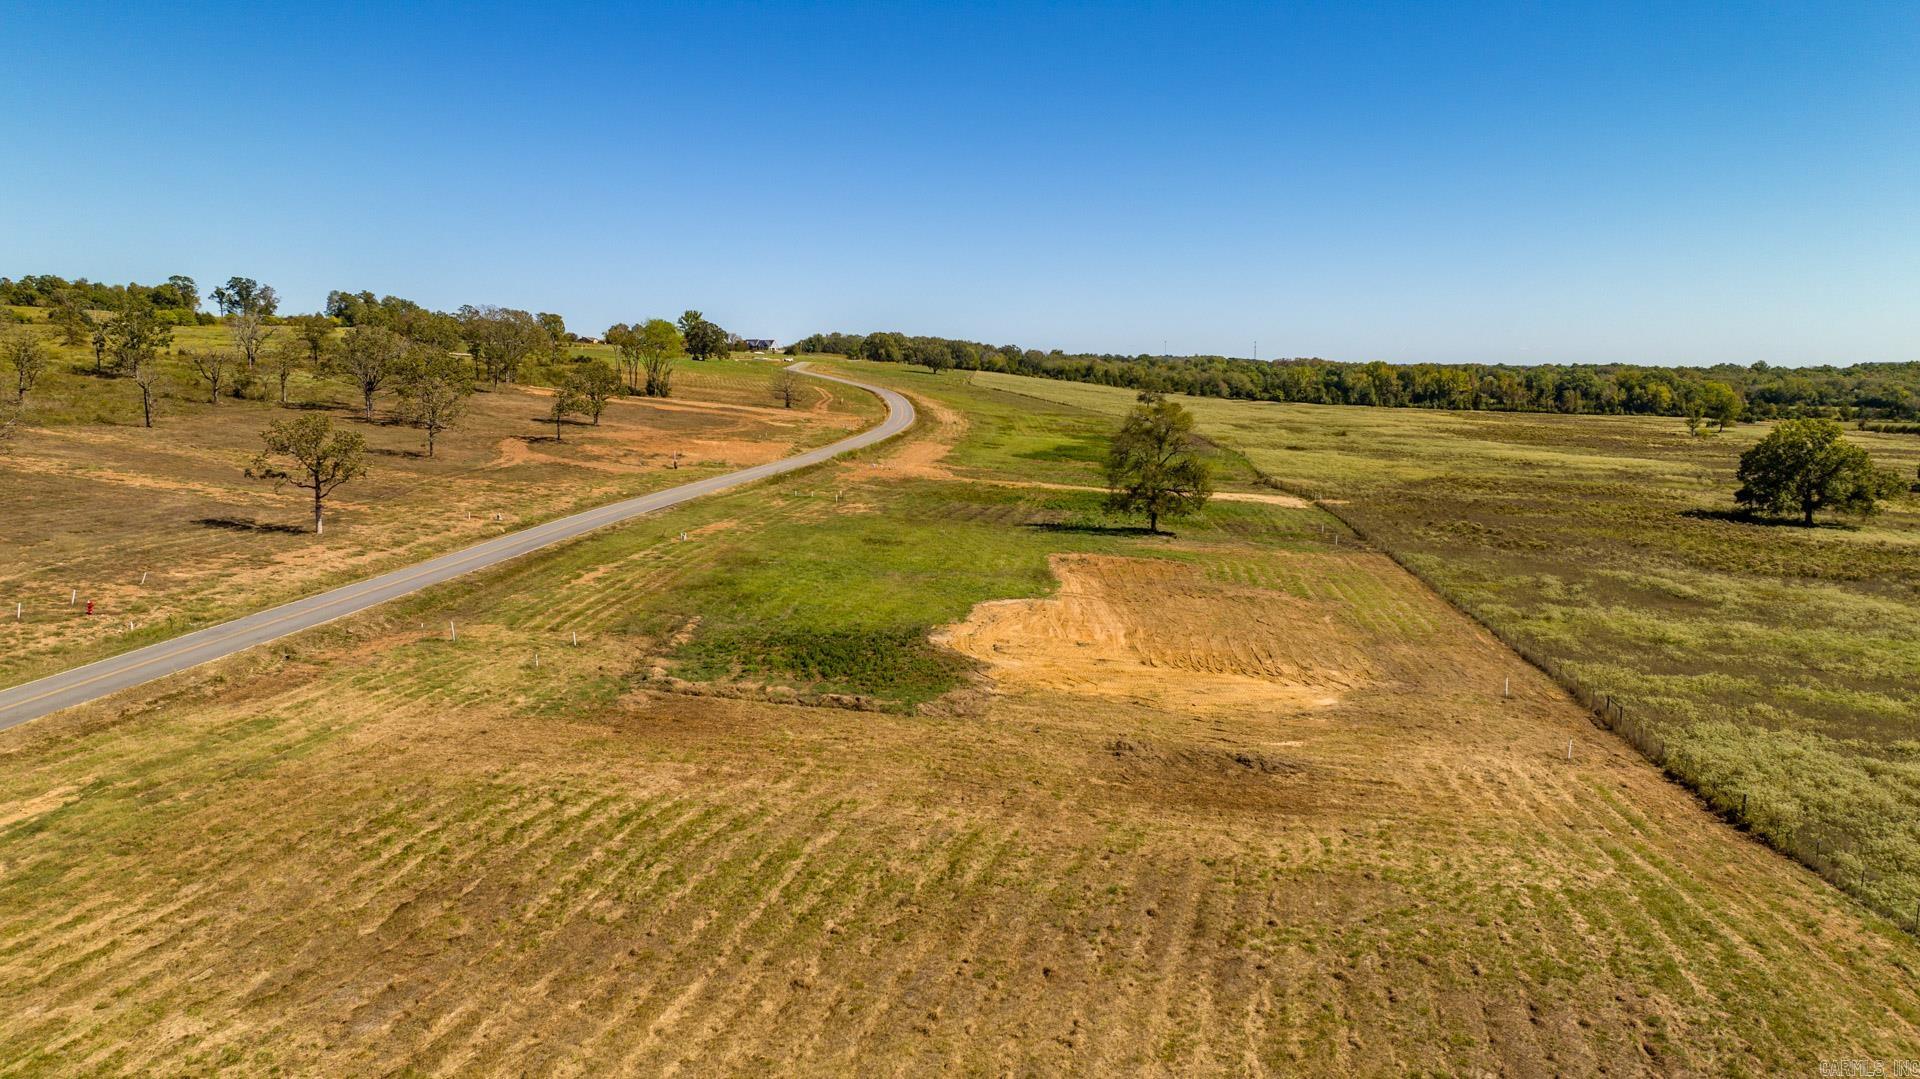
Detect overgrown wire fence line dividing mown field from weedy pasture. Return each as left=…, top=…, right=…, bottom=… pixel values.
left=1260, top=472, right=1920, bottom=933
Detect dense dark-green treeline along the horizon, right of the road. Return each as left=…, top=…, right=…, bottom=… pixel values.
left=787, top=332, right=1920, bottom=422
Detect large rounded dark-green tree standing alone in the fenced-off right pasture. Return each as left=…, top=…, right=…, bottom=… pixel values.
left=1734, top=419, right=1905, bottom=528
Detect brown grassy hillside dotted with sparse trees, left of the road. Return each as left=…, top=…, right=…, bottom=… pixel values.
left=0, top=314, right=881, bottom=685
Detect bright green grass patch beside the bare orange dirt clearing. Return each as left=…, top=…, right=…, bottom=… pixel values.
left=435, top=363, right=1297, bottom=708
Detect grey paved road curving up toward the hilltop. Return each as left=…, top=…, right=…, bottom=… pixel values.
left=0, top=365, right=914, bottom=730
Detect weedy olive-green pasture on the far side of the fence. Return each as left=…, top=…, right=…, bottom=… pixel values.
left=979, top=366, right=1920, bottom=916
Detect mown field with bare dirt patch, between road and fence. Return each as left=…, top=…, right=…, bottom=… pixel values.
left=0, top=367, right=1920, bottom=1075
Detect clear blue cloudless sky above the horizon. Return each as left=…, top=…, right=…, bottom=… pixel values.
left=0, top=0, right=1920, bottom=363
